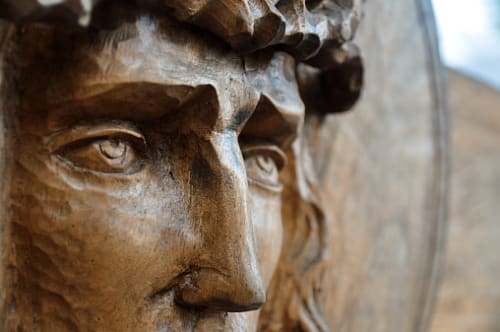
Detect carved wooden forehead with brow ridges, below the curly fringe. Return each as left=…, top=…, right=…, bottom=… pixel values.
left=9, top=17, right=304, bottom=138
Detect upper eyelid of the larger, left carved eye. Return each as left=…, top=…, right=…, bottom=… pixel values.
left=44, top=123, right=146, bottom=153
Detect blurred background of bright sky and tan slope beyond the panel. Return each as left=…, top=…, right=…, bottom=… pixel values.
left=432, top=0, right=500, bottom=332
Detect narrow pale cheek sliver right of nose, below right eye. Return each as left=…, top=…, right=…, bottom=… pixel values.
left=249, top=185, right=283, bottom=287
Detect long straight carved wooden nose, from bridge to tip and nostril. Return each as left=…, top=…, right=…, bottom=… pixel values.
left=176, top=132, right=265, bottom=311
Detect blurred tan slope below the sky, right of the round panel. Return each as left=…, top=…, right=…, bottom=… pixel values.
left=432, top=71, right=500, bottom=332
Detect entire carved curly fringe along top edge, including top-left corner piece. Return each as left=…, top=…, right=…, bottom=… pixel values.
left=0, top=0, right=362, bottom=59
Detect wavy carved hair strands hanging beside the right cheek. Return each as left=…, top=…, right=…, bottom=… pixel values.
left=259, top=130, right=329, bottom=332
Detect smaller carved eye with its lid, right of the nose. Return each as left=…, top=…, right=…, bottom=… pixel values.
left=242, top=145, right=286, bottom=190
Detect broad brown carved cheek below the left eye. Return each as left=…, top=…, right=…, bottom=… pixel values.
left=10, top=141, right=195, bottom=306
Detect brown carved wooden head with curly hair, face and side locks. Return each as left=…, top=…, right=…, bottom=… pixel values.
left=0, top=0, right=448, bottom=332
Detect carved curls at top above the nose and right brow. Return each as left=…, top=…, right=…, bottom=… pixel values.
left=158, top=0, right=360, bottom=59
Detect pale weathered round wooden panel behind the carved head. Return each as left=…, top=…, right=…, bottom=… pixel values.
left=312, top=0, right=454, bottom=332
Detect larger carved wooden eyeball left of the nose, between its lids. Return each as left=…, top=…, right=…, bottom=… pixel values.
left=59, top=137, right=145, bottom=173
